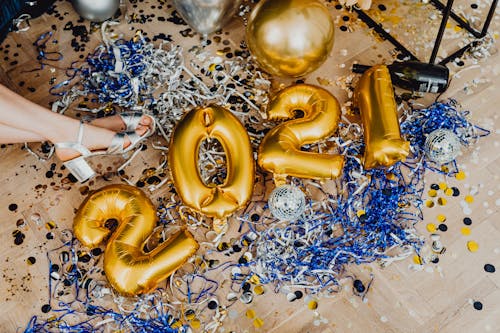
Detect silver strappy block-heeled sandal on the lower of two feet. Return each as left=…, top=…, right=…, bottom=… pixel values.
left=54, top=122, right=144, bottom=183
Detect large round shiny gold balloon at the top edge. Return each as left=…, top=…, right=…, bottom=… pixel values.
left=246, top=0, right=334, bottom=77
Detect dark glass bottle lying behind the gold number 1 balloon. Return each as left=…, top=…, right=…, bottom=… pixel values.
left=352, top=61, right=450, bottom=94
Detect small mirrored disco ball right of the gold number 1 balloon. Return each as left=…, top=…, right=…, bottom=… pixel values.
left=424, top=129, right=460, bottom=164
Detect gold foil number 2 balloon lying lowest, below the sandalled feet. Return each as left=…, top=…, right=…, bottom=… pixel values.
left=74, top=185, right=198, bottom=296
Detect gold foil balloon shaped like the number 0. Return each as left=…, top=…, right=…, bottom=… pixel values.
left=169, top=105, right=255, bottom=232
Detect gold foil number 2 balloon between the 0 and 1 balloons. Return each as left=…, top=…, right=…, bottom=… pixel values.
left=258, top=84, right=344, bottom=185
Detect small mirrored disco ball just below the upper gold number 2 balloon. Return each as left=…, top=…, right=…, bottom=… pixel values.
left=268, top=185, right=306, bottom=221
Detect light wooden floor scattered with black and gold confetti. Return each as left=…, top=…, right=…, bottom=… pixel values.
left=0, top=0, right=500, bottom=333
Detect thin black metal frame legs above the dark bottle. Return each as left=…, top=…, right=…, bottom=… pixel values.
left=354, top=0, right=498, bottom=65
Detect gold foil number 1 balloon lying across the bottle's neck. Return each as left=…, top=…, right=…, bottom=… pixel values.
left=354, top=65, right=410, bottom=169
